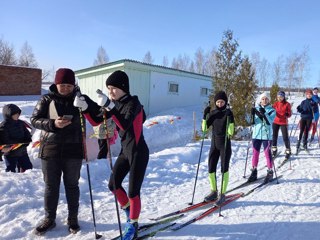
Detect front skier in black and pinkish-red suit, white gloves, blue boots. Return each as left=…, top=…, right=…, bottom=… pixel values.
left=74, top=71, right=149, bottom=240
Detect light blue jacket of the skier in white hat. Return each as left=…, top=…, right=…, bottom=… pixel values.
left=252, top=104, right=276, bottom=140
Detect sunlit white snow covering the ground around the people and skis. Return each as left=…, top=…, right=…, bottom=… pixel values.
left=0, top=89, right=320, bottom=240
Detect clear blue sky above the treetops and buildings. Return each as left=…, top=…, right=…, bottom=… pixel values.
left=0, top=0, right=320, bottom=86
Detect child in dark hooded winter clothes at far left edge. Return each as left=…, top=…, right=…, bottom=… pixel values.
left=0, top=104, right=33, bottom=172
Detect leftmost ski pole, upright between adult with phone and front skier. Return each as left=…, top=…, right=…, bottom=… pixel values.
left=77, top=98, right=102, bottom=239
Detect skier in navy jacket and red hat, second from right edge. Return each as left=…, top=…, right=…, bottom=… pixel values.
left=297, top=89, right=317, bottom=150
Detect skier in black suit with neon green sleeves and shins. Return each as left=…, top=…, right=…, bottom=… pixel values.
left=202, top=91, right=234, bottom=205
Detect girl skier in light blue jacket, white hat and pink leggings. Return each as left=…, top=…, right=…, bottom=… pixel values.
left=248, top=92, right=276, bottom=182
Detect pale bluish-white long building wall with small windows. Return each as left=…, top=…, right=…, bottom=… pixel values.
left=149, top=72, right=212, bottom=113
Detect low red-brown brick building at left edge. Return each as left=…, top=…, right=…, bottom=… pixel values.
left=0, top=64, right=42, bottom=96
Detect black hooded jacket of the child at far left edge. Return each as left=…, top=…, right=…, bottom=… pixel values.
left=0, top=104, right=32, bottom=157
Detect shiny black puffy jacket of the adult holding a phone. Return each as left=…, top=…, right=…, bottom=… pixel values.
left=31, top=84, right=85, bottom=159
